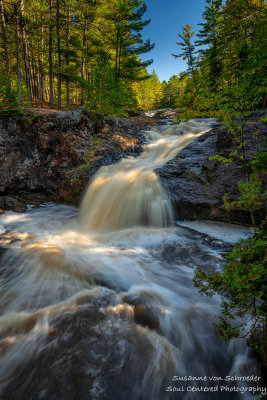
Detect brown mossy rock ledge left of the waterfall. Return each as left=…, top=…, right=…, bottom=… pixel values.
left=0, top=110, right=158, bottom=212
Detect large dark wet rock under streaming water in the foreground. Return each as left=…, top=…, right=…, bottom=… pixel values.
left=0, top=289, right=174, bottom=400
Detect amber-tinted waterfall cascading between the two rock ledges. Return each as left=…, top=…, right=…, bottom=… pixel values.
left=80, top=120, right=213, bottom=231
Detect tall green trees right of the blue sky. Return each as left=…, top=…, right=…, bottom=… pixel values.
left=173, top=0, right=267, bottom=111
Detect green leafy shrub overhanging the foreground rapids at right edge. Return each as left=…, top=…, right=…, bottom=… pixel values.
left=193, top=221, right=267, bottom=351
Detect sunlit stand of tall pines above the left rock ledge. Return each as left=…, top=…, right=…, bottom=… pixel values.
left=0, top=0, right=154, bottom=113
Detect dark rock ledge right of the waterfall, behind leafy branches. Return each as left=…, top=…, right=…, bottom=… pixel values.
left=157, top=112, right=267, bottom=225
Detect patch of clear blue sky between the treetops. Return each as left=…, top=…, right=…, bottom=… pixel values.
left=142, top=0, right=206, bottom=81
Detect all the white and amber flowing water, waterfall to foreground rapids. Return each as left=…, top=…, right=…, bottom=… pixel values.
left=0, top=120, right=260, bottom=400
